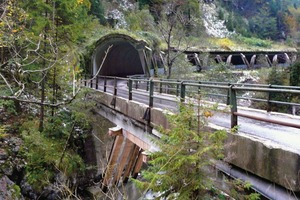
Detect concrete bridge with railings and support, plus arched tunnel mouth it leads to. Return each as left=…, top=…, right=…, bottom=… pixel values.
left=85, top=32, right=300, bottom=199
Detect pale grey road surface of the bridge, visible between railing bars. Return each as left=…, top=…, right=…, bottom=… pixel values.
left=94, top=80, right=300, bottom=154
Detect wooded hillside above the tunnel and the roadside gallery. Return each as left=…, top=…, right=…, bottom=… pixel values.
left=91, top=0, right=300, bottom=50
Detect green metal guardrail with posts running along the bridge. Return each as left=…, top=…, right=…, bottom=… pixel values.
left=85, top=76, right=300, bottom=129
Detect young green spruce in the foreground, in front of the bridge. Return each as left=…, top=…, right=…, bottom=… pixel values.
left=135, top=105, right=227, bottom=199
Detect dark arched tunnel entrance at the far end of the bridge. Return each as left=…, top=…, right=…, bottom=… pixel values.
left=92, top=34, right=151, bottom=77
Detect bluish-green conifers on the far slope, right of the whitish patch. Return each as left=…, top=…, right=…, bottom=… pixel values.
left=220, top=0, right=295, bottom=40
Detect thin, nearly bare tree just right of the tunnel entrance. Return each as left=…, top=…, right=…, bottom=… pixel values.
left=152, top=0, right=199, bottom=78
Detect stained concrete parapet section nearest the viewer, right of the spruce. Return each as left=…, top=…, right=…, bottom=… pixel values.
left=225, top=134, right=300, bottom=192
